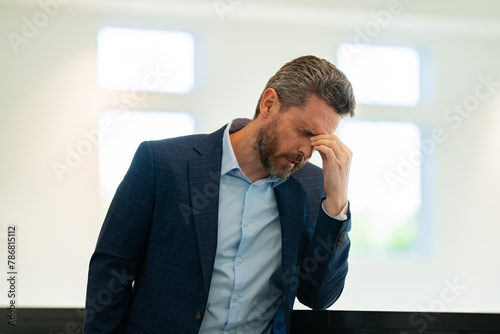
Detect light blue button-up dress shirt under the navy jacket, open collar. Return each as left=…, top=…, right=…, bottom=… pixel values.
left=200, top=124, right=285, bottom=334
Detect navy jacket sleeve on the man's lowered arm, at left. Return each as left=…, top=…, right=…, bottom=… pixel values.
left=84, top=142, right=155, bottom=334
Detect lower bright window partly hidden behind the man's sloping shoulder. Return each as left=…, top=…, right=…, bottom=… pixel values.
left=99, top=110, right=195, bottom=211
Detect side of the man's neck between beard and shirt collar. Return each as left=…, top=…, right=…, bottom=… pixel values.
left=229, top=120, right=269, bottom=183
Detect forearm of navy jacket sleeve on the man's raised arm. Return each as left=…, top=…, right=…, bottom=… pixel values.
left=297, top=201, right=351, bottom=309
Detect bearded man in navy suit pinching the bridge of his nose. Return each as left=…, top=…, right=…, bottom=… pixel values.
left=84, top=56, right=355, bottom=334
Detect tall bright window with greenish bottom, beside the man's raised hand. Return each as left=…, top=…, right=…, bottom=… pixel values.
left=312, top=120, right=428, bottom=255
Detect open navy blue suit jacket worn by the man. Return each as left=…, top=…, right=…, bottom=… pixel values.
left=84, top=127, right=350, bottom=334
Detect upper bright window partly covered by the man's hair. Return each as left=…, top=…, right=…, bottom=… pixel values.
left=337, top=43, right=420, bottom=106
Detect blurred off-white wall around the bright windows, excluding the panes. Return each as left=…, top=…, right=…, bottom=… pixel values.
left=0, top=0, right=500, bottom=312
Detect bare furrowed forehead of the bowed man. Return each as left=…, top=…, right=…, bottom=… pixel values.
left=285, top=95, right=342, bottom=135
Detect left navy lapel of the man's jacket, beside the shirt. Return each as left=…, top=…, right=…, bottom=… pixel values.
left=188, top=127, right=225, bottom=294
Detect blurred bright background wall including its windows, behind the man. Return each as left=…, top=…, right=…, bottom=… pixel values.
left=0, top=0, right=500, bottom=313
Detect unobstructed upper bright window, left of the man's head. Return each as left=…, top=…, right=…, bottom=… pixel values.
left=97, top=27, right=194, bottom=94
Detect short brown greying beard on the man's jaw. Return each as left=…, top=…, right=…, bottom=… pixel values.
left=255, top=120, right=307, bottom=179
